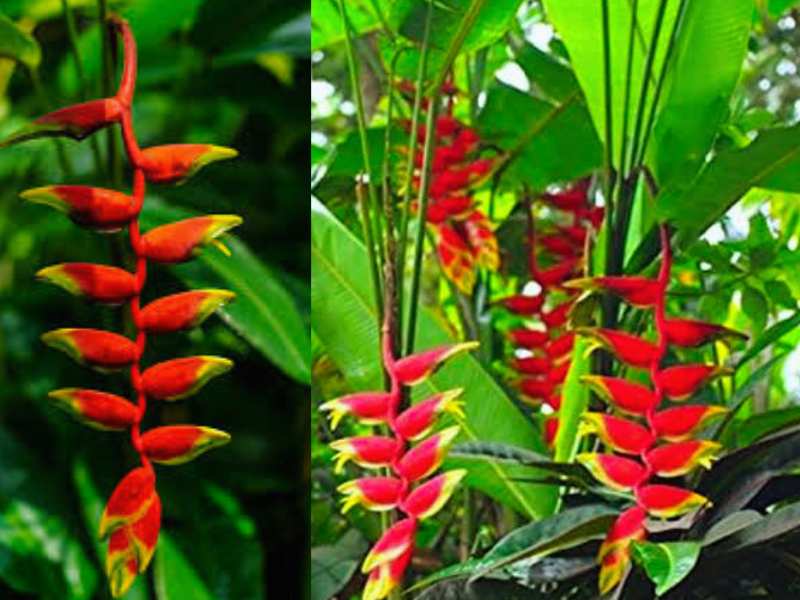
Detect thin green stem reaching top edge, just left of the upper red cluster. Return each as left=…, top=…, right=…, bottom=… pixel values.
left=397, top=3, right=433, bottom=338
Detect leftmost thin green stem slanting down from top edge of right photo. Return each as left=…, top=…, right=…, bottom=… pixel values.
left=339, top=0, right=384, bottom=314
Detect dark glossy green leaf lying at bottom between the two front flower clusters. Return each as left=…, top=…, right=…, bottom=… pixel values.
left=470, top=504, right=619, bottom=581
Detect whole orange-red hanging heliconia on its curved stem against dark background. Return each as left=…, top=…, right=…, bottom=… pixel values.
left=10, top=17, right=241, bottom=597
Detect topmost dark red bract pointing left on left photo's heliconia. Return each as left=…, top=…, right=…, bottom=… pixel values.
left=3, top=98, right=122, bottom=145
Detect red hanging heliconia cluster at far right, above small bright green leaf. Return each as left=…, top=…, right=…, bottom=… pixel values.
left=568, top=226, right=743, bottom=593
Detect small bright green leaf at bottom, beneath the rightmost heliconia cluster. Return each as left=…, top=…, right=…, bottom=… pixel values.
left=632, top=542, right=701, bottom=596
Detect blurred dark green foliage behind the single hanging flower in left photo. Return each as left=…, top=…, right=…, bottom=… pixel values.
left=0, top=0, right=310, bottom=600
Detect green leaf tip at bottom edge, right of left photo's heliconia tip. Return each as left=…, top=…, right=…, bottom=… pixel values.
left=153, top=531, right=215, bottom=600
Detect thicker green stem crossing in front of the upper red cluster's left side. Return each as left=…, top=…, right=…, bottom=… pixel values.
left=403, top=96, right=440, bottom=356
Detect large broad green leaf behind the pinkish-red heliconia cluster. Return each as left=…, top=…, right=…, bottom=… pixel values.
left=311, top=199, right=555, bottom=518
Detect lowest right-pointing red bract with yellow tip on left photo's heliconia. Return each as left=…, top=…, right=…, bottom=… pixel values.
left=142, top=425, right=231, bottom=465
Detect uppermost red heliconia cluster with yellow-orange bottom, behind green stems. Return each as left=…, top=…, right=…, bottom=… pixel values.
left=400, top=82, right=500, bottom=294
